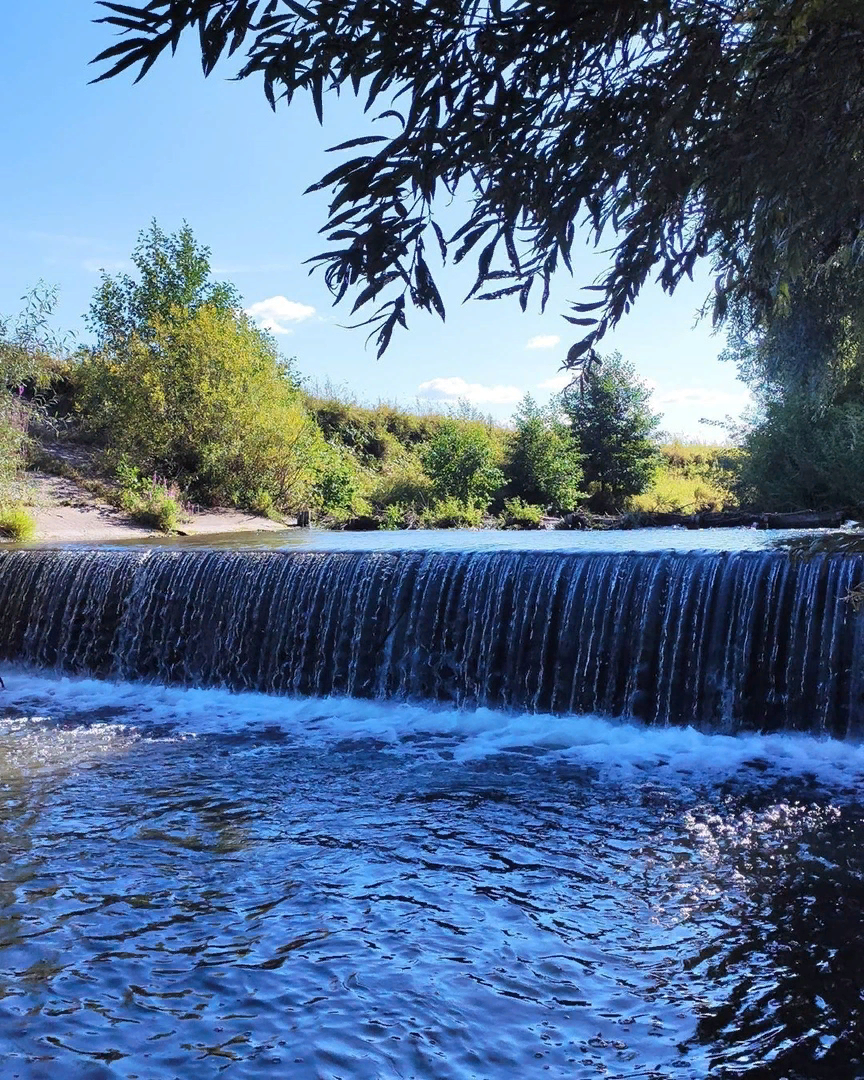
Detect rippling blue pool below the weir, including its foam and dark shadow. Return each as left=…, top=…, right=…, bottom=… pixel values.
left=0, top=674, right=864, bottom=1080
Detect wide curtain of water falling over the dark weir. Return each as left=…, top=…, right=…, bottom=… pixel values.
left=0, top=550, right=864, bottom=737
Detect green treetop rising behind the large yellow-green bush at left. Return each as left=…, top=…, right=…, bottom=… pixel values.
left=86, top=221, right=242, bottom=346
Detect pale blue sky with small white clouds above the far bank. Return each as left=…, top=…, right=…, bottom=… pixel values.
left=0, top=0, right=747, bottom=440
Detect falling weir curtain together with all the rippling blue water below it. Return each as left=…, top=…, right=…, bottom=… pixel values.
left=0, top=535, right=864, bottom=1080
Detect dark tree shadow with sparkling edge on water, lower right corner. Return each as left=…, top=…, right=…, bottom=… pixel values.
left=685, top=790, right=864, bottom=1080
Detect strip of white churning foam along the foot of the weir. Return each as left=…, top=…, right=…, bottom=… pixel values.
left=0, top=670, right=864, bottom=786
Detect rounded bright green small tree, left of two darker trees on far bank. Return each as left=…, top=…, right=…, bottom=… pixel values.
left=422, top=417, right=503, bottom=507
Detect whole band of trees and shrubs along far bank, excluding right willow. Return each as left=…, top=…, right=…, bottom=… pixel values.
left=0, top=222, right=743, bottom=530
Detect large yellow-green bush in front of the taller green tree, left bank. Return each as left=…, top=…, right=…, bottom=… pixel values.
left=77, top=306, right=327, bottom=509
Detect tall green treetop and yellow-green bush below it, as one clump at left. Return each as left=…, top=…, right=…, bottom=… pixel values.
left=75, top=221, right=326, bottom=509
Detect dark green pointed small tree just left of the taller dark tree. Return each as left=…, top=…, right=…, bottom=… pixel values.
left=504, top=394, right=584, bottom=511
